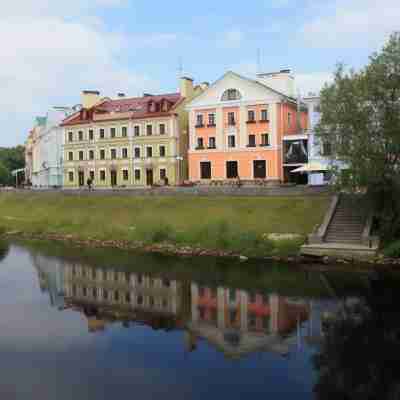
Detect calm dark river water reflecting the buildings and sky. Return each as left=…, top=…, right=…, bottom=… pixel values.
left=0, top=239, right=400, bottom=400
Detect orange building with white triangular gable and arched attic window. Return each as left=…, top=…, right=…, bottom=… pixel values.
left=187, top=70, right=308, bottom=183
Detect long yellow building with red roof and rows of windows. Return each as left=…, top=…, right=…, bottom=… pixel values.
left=62, top=77, right=206, bottom=188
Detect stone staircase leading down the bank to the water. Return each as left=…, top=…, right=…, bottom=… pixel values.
left=324, top=195, right=366, bottom=245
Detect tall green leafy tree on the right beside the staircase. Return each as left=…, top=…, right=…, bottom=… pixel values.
left=317, top=33, right=400, bottom=238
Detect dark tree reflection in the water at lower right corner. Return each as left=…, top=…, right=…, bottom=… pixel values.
left=314, top=275, right=400, bottom=400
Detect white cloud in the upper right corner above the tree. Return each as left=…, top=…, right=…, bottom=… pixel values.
left=301, top=0, right=400, bottom=48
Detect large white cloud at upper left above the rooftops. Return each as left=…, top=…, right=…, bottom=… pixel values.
left=0, top=0, right=163, bottom=146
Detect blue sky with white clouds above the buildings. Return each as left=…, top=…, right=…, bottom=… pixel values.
left=0, top=0, right=400, bottom=147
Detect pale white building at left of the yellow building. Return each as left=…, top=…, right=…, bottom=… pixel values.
left=29, top=108, right=72, bottom=188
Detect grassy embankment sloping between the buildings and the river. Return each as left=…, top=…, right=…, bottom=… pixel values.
left=0, top=193, right=329, bottom=256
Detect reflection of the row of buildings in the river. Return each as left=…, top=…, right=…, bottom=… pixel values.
left=33, top=255, right=337, bottom=358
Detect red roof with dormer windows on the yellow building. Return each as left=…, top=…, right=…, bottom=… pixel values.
left=62, top=93, right=183, bottom=126
